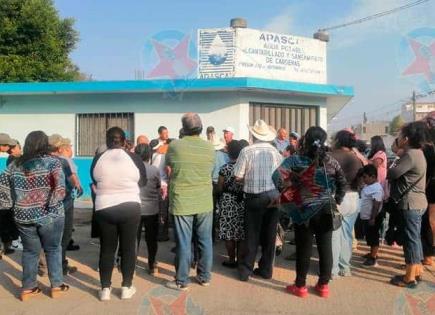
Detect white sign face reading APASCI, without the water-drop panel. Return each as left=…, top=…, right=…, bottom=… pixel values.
left=235, top=28, right=327, bottom=84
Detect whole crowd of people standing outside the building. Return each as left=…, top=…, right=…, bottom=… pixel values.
left=0, top=113, right=435, bottom=301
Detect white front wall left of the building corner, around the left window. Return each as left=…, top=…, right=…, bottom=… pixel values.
left=0, top=92, right=245, bottom=146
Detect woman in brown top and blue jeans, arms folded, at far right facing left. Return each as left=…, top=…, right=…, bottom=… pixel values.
left=387, top=122, right=428, bottom=288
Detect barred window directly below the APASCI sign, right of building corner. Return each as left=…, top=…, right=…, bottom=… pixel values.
left=249, top=102, right=319, bottom=135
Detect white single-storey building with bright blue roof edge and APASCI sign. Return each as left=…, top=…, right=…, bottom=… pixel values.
left=0, top=21, right=353, bottom=196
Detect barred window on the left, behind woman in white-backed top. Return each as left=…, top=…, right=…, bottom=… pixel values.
left=76, top=113, right=134, bottom=156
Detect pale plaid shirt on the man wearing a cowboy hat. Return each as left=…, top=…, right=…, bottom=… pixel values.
left=234, top=142, right=282, bottom=194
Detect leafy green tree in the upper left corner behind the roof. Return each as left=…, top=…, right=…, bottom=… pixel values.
left=0, top=0, right=80, bottom=82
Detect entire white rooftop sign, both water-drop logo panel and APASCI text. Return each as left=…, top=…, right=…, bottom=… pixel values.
left=198, top=28, right=327, bottom=84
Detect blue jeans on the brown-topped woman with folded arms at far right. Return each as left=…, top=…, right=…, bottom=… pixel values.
left=402, top=209, right=426, bottom=264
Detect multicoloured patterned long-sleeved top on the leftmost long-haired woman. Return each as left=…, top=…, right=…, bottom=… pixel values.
left=0, top=156, right=65, bottom=224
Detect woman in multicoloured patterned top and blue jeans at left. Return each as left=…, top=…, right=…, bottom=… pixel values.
left=0, top=131, right=69, bottom=301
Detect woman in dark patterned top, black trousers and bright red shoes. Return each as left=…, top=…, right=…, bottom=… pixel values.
left=272, top=127, right=346, bottom=297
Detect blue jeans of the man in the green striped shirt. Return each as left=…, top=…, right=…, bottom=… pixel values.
left=174, top=212, right=213, bottom=285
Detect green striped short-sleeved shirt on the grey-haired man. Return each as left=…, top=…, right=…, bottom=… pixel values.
left=166, top=136, right=215, bottom=215
